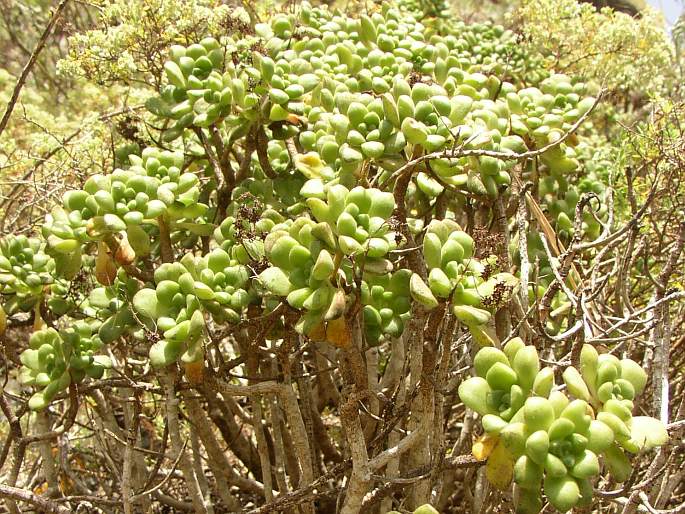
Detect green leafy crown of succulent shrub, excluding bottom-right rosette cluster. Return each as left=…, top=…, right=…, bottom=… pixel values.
left=6, top=1, right=600, bottom=416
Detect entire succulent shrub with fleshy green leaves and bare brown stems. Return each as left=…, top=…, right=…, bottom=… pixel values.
left=0, top=0, right=677, bottom=514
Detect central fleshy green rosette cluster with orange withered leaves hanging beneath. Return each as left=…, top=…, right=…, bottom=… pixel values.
left=259, top=179, right=400, bottom=344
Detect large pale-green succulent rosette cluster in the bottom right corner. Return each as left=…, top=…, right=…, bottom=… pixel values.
left=458, top=338, right=668, bottom=513
